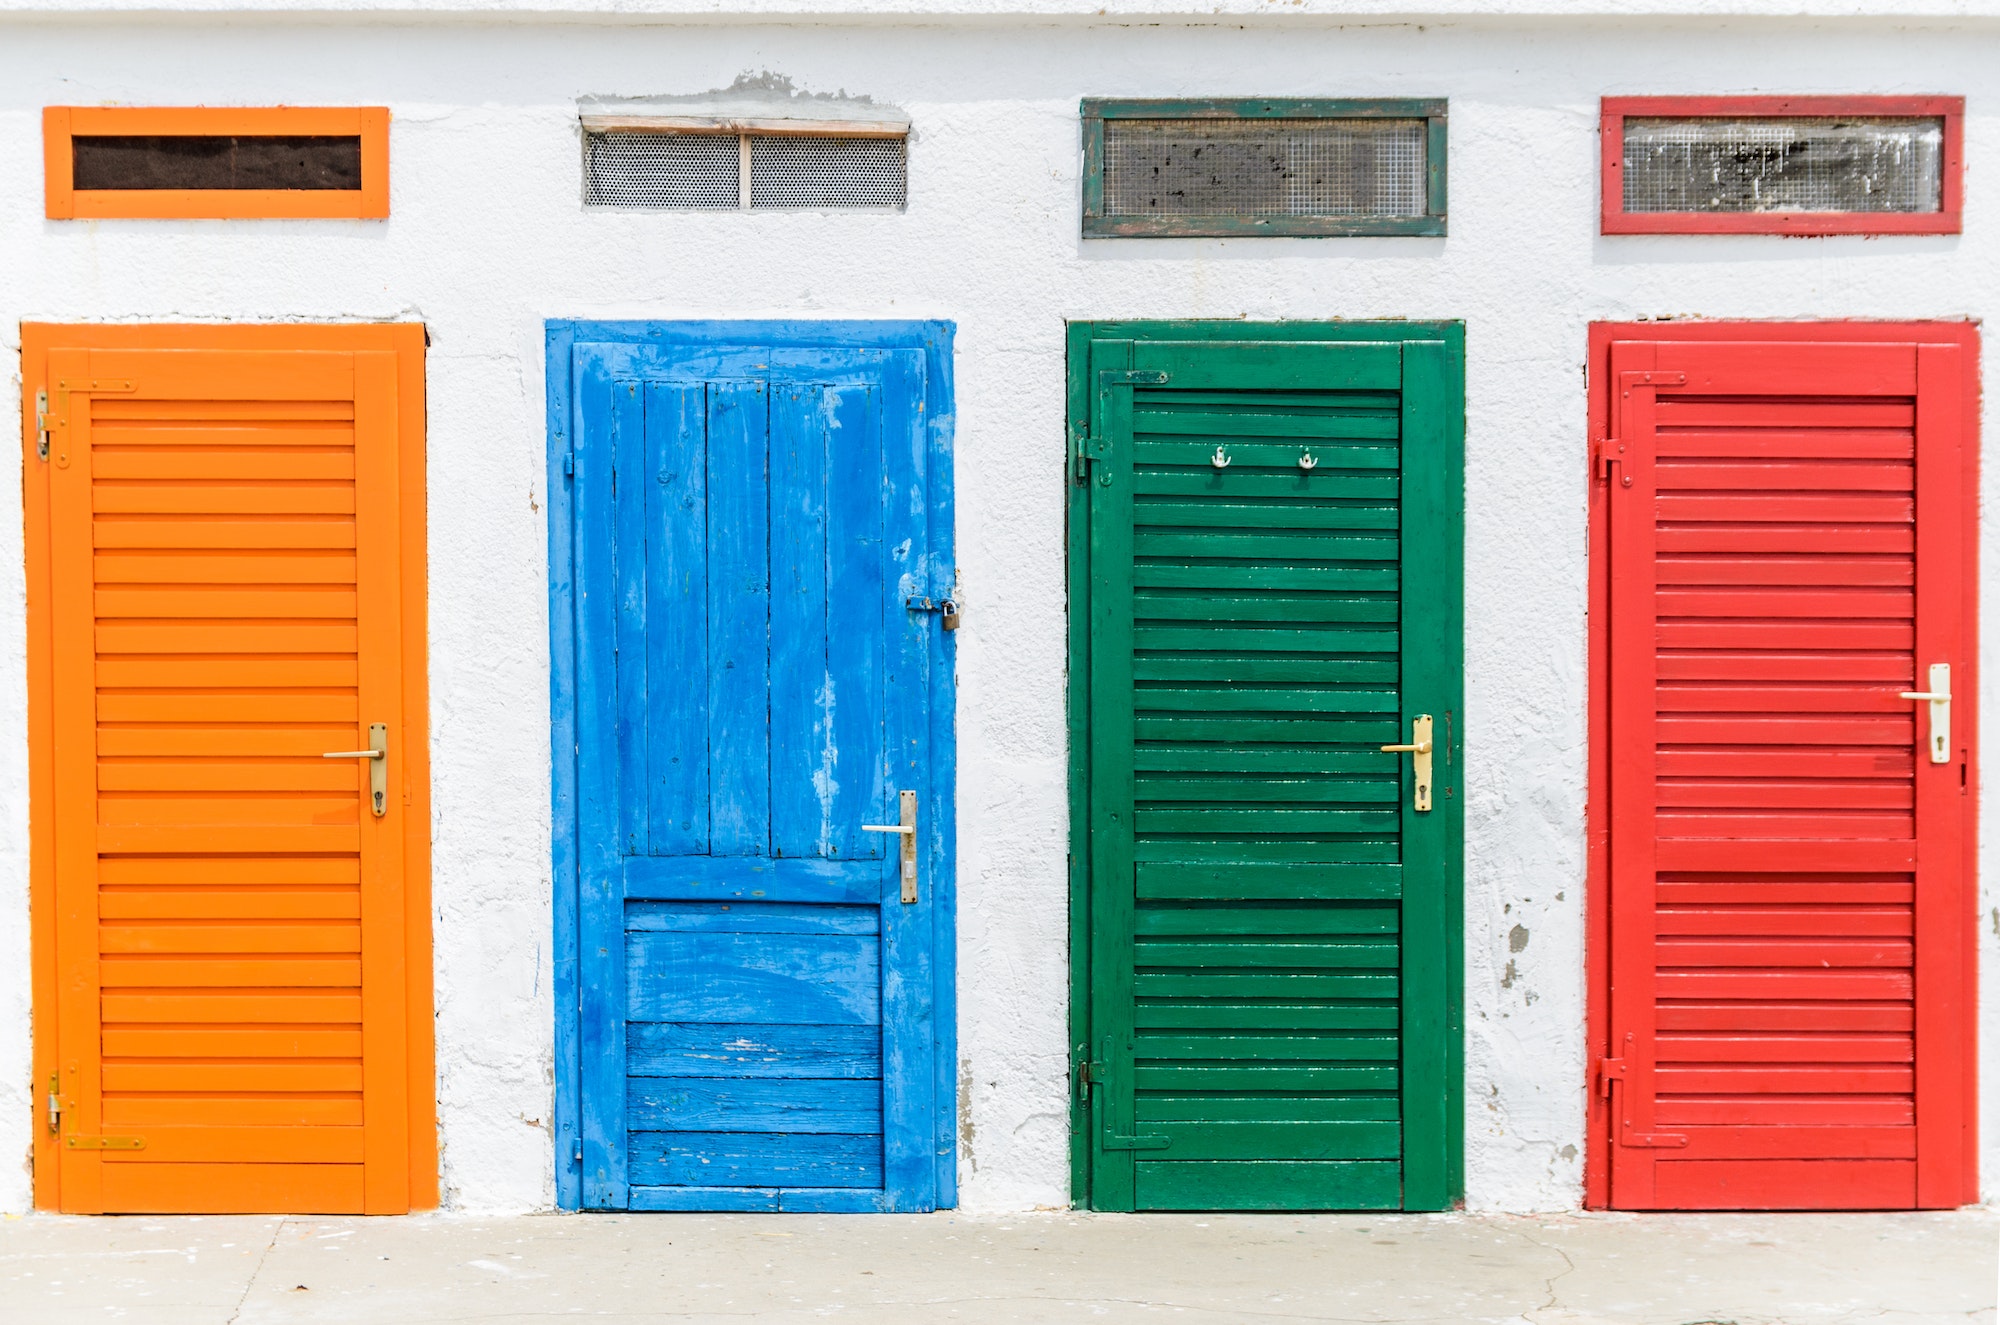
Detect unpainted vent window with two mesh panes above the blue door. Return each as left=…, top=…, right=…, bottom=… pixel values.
left=584, top=132, right=908, bottom=210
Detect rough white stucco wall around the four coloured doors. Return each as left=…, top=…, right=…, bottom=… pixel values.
left=0, top=13, right=2000, bottom=1211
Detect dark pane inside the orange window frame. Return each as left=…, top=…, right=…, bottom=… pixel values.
left=72, top=134, right=362, bottom=190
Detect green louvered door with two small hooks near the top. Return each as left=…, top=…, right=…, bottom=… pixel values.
left=1070, top=324, right=1464, bottom=1209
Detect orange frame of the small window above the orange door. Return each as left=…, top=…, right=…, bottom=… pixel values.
left=42, top=106, right=388, bottom=220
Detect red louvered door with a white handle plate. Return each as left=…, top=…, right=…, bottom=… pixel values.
left=1594, top=328, right=1976, bottom=1209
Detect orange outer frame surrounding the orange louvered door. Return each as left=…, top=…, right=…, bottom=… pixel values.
left=20, top=322, right=438, bottom=1211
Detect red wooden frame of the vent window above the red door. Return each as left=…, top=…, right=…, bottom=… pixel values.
left=1598, top=96, right=1966, bottom=236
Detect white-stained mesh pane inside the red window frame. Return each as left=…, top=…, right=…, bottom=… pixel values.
left=1624, top=118, right=1944, bottom=212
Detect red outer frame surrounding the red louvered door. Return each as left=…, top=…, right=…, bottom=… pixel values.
left=1584, top=322, right=1980, bottom=1209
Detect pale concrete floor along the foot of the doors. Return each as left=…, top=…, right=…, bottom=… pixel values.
left=0, top=1211, right=2000, bottom=1325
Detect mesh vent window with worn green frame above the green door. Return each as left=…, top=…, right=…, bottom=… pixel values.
left=1084, top=100, right=1444, bottom=236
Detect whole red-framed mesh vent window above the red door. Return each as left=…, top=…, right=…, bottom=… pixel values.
left=1606, top=98, right=1958, bottom=234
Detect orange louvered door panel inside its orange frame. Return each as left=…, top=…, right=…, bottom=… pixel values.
left=40, top=340, right=420, bottom=1213
